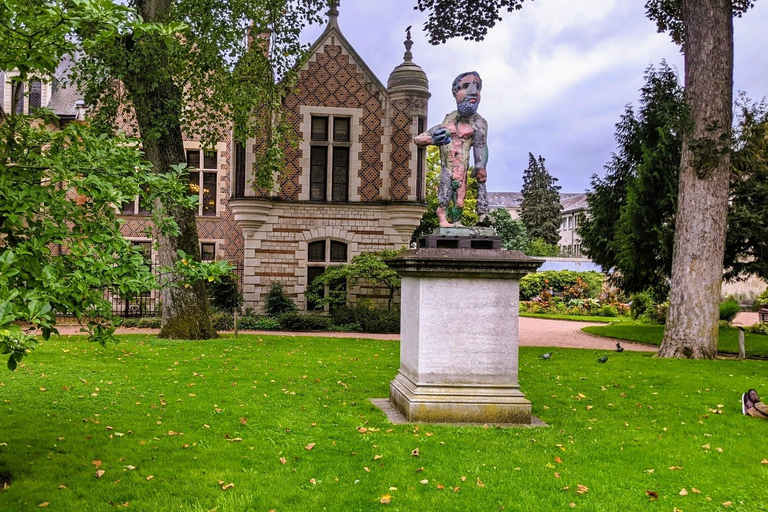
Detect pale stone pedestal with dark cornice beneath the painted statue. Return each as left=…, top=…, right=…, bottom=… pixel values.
left=387, top=248, right=542, bottom=424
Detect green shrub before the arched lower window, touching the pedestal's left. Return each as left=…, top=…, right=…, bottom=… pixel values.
left=304, top=248, right=405, bottom=311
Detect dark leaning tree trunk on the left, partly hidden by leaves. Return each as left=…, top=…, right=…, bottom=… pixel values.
left=124, top=0, right=217, bottom=340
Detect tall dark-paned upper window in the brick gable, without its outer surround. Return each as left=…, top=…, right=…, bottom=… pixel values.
left=309, top=115, right=352, bottom=202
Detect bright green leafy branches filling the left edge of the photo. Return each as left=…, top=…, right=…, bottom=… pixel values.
left=0, top=0, right=226, bottom=370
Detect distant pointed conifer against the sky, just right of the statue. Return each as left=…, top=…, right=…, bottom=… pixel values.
left=520, top=153, right=563, bottom=245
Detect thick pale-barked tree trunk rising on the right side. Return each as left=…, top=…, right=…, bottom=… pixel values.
left=659, top=0, right=733, bottom=359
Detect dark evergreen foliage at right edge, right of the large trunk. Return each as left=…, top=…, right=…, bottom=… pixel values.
left=725, top=96, right=768, bottom=279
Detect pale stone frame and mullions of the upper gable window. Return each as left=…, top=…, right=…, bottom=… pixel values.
left=299, top=105, right=363, bottom=203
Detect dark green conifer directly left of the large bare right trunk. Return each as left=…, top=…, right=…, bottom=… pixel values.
left=579, top=62, right=685, bottom=300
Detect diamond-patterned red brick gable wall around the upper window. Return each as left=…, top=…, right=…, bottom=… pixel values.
left=276, top=45, right=384, bottom=202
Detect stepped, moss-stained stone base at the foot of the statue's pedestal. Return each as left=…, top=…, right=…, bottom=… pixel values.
left=389, top=373, right=531, bottom=425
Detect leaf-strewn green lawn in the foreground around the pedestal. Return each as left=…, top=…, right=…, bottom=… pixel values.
left=0, top=335, right=768, bottom=512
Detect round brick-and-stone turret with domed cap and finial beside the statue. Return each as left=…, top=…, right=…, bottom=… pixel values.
left=387, top=27, right=431, bottom=202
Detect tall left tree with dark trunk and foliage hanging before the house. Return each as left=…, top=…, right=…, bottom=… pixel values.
left=78, top=0, right=326, bottom=339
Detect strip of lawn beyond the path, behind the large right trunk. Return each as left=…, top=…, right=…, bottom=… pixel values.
left=582, top=322, right=768, bottom=357
